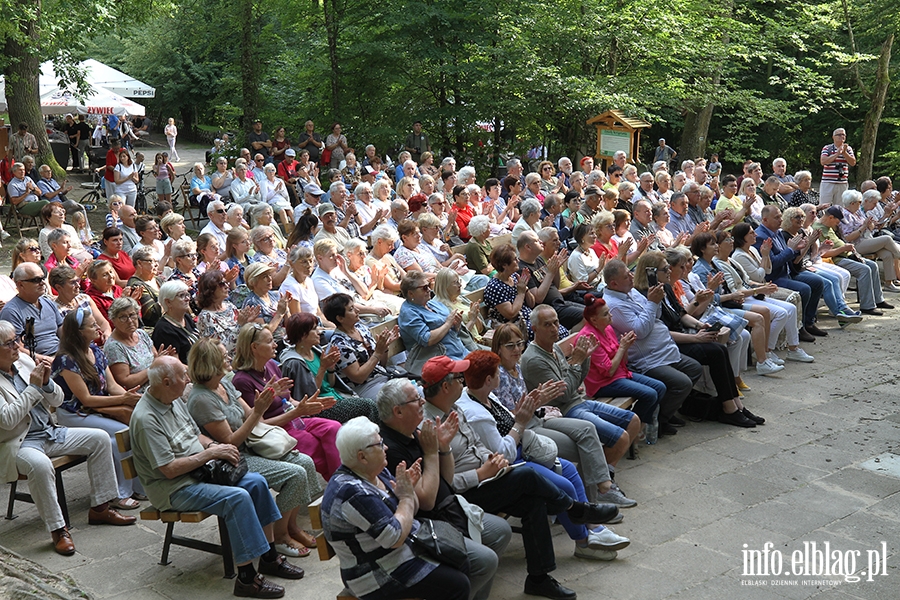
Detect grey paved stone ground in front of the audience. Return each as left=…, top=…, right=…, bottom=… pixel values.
left=0, top=139, right=900, bottom=600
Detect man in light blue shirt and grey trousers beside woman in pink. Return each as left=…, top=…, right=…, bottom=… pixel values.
left=604, top=260, right=703, bottom=435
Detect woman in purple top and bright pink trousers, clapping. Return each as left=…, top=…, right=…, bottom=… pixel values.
left=232, top=323, right=341, bottom=480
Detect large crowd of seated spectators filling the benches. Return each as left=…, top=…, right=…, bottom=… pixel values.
left=7, top=130, right=900, bottom=599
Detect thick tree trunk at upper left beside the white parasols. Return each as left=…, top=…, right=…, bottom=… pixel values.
left=3, top=0, right=66, bottom=181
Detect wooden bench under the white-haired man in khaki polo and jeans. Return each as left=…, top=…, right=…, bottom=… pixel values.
left=116, top=429, right=235, bottom=579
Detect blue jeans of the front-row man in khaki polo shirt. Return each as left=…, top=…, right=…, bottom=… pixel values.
left=169, top=472, right=281, bottom=565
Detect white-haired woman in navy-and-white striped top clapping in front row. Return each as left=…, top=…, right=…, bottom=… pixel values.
left=322, top=417, right=469, bottom=600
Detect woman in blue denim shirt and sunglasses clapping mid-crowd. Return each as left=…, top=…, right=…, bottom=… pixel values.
left=398, top=271, right=468, bottom=375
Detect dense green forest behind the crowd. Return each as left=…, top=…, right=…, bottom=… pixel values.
left=0, top=0, right=900, bottom=176
